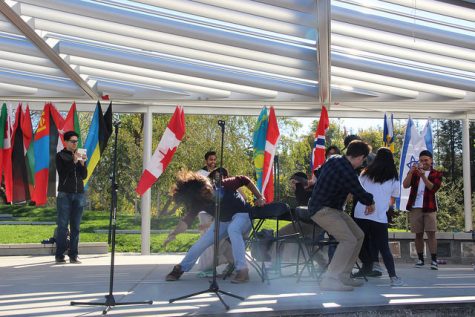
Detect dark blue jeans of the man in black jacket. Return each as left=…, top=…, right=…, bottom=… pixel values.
left=56, top=192, right=84, bottom=258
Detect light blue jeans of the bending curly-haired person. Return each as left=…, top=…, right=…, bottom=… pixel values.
left=180, top=213, right=251, bottom=272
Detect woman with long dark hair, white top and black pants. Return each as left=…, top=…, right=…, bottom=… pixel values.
left=355, top=147, right=403, bottom=286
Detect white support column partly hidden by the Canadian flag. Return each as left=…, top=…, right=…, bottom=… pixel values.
left=140, top=107, right=153, bottom=255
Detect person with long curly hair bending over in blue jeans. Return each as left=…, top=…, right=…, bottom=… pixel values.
left=165, top=169, right=265, bottom=283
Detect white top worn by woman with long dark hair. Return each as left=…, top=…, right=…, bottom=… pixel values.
left=355, top=175, right=400, bottom=223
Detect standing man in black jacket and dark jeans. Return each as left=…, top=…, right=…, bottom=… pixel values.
left=55, top=131, right=87, bottom=263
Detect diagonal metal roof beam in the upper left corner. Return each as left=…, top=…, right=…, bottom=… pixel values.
left=0, top=1, right=99, bottom=99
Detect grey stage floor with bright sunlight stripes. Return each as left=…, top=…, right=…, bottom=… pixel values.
left=0, top=254, right=475, bottom=316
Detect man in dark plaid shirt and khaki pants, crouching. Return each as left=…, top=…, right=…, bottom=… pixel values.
left=308, top=140, right=374, bottom=291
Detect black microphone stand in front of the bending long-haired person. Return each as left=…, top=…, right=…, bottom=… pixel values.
left=169, top=120, right=244, bottom=310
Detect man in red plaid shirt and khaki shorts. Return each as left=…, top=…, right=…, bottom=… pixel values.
left=402, top=150, right=442, bottom=270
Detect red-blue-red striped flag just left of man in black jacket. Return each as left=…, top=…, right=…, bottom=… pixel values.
left=33, top=103, right=64, bottom=206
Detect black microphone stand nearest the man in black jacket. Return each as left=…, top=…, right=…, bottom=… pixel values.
left=71, top=121, right=152, bottom=315
